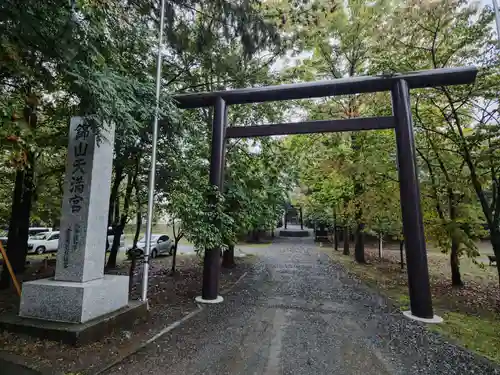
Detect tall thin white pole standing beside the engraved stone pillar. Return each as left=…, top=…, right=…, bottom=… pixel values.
left=141, top=0, right=165, bottom=301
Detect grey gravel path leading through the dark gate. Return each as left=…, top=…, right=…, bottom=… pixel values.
left=102, top=239, right=500, bottom=375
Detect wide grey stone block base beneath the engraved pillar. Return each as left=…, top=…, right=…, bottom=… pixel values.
left=19, top=275, right=129, bottom=323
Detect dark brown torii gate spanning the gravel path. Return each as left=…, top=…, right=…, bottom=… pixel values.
left=174, top=67, right=477, bottom=322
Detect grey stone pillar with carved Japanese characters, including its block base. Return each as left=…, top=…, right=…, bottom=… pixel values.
left=19, top=117, right=128, bottom=323
